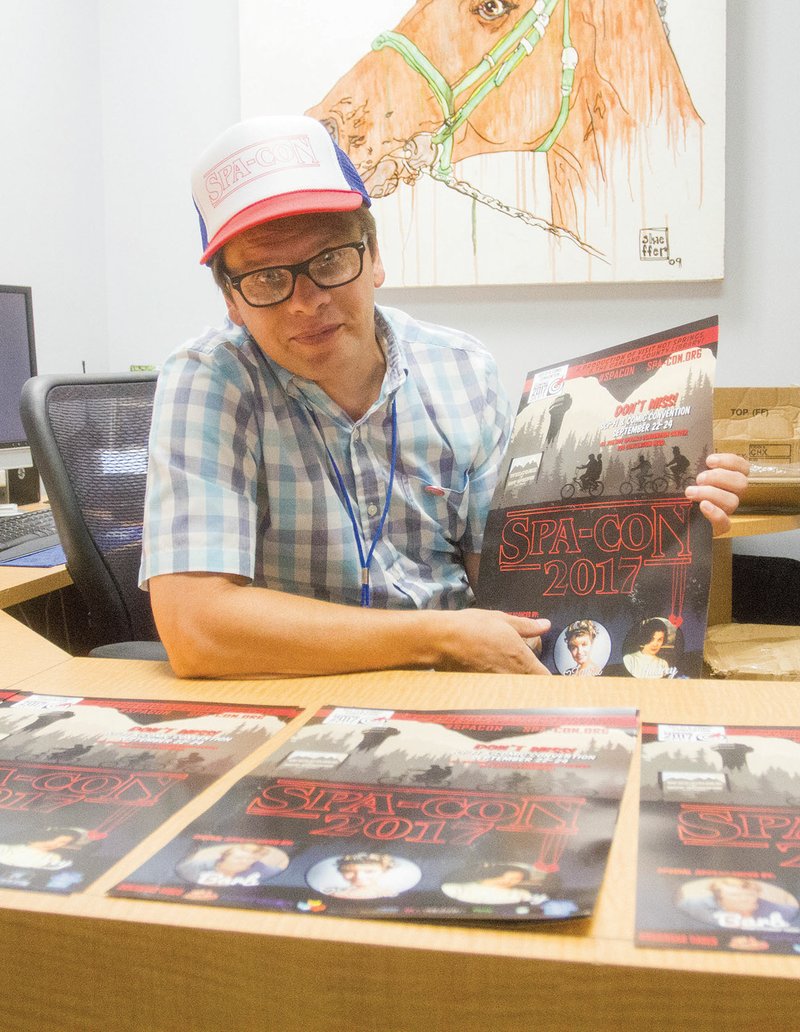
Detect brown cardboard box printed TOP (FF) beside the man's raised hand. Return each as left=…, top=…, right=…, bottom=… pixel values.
left=713, top=387, right=800, bottom=512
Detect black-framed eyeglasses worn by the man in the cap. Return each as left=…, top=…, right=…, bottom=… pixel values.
left=227, top=240, right=366, bottom=309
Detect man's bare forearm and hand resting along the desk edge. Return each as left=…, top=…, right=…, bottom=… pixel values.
left=150, top=574, right=541, bottom=677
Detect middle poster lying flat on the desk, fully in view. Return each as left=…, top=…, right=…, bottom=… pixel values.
left=111, top=706, right=638, bottom=921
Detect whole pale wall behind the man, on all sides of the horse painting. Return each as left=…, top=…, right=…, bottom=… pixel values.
left=0, top=0, right=800, bottom=555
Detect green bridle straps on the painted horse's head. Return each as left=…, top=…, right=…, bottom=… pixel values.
left=373, top=0, right=578, bottom=180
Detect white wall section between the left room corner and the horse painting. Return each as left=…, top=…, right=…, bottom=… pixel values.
left=97, top=0, right=239, bottom=368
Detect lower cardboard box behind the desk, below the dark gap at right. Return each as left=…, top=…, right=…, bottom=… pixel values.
left=703, top=623, right=800, bottom=681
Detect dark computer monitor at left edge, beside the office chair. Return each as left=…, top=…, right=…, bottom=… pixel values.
left=0, top=285, right=36, bottom=470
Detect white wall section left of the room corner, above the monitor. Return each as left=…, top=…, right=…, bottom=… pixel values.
left=0, top=0, right=108, bottom=372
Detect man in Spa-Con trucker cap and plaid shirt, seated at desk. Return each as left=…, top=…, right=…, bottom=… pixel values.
left=141, top=117, right=746, bottom=677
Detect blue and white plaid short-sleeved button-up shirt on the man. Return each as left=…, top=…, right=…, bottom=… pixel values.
left=141, top=309, right=512, bottom=609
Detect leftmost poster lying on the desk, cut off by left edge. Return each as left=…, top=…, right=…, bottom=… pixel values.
left=0, top=691, right=300, bottom=893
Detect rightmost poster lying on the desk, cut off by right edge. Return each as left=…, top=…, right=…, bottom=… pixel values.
left=636, top=723, right=800, bottom=956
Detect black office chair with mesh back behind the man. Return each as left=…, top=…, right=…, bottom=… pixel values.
left=20, top=373, right=166, bottom=659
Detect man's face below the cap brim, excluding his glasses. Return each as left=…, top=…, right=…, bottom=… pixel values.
left=223, top=213, right=384, bottom=387
